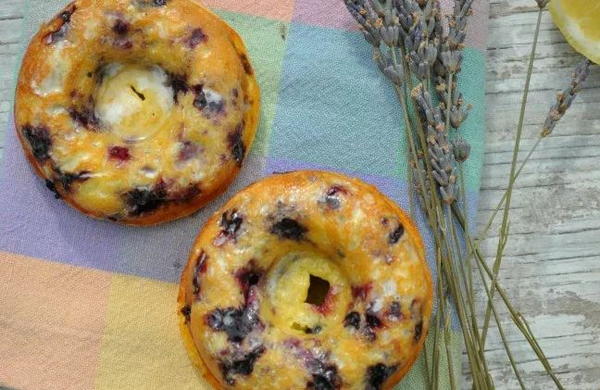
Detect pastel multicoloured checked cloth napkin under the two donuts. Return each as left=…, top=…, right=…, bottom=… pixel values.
left=0, top=0, right=487, bottom=390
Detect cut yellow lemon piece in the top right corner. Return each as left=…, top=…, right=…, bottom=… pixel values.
left=549, top=0, right=600, bottom=64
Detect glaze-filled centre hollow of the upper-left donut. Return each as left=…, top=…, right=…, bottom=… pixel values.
left=93, top=63, right=174, bottom=142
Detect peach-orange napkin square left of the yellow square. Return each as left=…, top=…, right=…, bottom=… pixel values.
left=0, top=252, right=111, bottom=390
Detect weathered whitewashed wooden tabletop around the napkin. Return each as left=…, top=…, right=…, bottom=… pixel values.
left=0, top=0, right=600, bottom=390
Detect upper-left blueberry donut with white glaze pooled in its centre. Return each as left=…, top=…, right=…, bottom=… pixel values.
left=15, top=0, right=259, bottom=225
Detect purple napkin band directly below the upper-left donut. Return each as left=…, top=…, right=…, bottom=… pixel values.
left=0, top=119, right=264, bottom=282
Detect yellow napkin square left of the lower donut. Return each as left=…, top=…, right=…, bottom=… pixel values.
left=96, top=275, right=210, bottom=390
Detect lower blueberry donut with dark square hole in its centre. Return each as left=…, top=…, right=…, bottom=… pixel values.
left=178, top=171, right=432, bottom=390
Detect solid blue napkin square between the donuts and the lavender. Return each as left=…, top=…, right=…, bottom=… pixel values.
left=267, top=23, right=406, bottom=178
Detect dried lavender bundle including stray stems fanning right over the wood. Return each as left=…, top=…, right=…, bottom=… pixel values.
left=344, top=0, right=568, bottom=389
